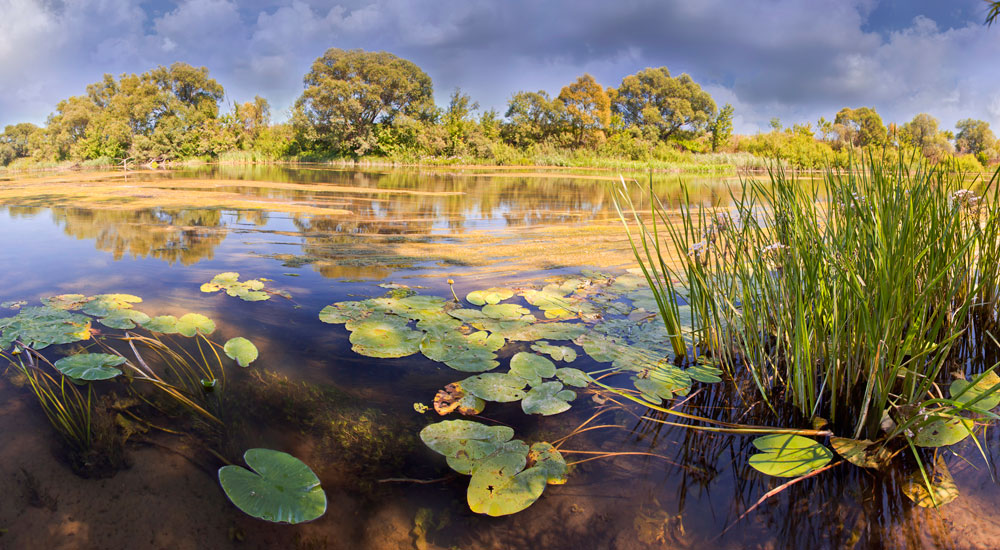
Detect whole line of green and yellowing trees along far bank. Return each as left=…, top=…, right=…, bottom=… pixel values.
left=0, top=48, right=1000, bottom=168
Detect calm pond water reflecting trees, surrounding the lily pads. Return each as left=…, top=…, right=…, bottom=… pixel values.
left=0, top=166, right=1000, bottom=549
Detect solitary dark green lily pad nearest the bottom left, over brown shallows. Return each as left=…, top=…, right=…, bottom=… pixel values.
left=219, top=449, right=326, bottom=524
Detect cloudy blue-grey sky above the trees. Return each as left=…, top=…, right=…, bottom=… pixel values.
left=0, top=0, right=1000, bottom=134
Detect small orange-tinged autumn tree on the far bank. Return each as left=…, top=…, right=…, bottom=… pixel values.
left=503, top=90, right=566, bottom=147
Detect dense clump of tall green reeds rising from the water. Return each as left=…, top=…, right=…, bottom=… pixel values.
left=616, top=158, right=1000, bottom=438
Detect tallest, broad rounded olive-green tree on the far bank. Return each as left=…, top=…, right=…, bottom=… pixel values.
left=294, top=48, right=434, bottom=154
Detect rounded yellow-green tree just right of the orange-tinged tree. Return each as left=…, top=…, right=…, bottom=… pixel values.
left=612, top=67, right=715, bottom=140
